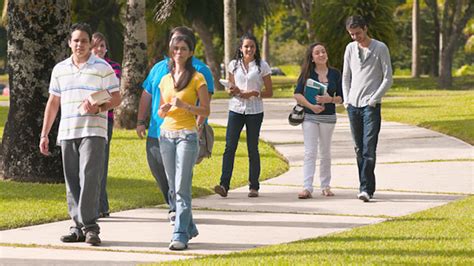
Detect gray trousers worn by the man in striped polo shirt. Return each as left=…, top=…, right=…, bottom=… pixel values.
left=61, top=137, right=106, bottom=234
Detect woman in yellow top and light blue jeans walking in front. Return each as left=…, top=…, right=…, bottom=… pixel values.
left=158, top=36, right=210, bottom=250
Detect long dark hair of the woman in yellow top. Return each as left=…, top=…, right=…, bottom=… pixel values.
left=168, top=35, right=196, bottom=91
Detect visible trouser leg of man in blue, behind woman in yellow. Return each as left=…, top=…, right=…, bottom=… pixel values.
left=146, top=137, right=176, bottom=212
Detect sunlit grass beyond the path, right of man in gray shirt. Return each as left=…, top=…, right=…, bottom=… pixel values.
left=382, top=76, right=474, bottom=144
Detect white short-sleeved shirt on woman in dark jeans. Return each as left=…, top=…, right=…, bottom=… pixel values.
left=228, top=60, right=271, bottom=115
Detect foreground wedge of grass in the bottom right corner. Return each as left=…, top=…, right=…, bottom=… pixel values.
left=162, top=196, right=474, bottom=265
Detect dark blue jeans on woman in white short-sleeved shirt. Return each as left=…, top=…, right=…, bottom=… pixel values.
left=220, top=111, right=263, bottom=191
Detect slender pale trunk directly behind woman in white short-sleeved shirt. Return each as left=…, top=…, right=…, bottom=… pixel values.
left=224, top=0, right=237, bottom=78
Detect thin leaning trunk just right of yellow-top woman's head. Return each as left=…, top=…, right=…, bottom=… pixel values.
left=193, top=19, right=223, bottom=90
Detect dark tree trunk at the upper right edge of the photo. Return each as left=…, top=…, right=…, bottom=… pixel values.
left=438, top=0, right=474, bottom=88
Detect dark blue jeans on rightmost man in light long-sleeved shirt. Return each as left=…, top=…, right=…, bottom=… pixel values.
left=347, top=104, right=381, bottom=196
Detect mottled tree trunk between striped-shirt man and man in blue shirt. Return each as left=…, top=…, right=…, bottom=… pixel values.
left=115, top=0, right=147, bottom=129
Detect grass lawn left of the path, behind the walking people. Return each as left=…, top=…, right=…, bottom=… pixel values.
left=0, top=124, right=288, bottom=230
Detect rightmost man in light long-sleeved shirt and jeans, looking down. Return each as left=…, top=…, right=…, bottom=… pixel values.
left=342, top=16, right=392, bottom=202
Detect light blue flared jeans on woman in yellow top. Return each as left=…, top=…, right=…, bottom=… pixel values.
left=160, top=132, right=199, bottom=244
